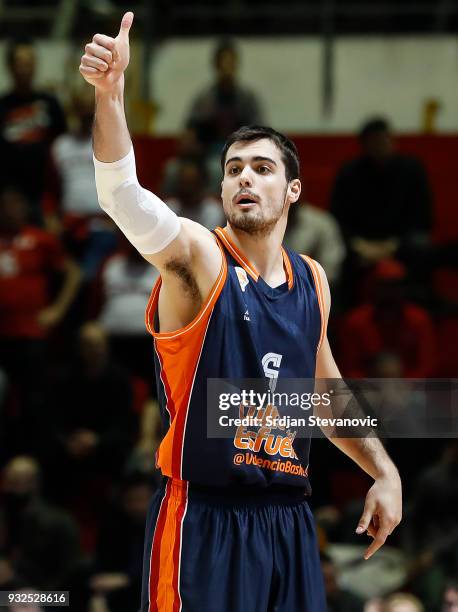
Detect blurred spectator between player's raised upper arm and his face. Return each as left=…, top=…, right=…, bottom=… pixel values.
left=165, top=160, right=225, bottom=230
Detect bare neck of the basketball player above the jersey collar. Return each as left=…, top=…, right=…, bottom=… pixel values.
left=225, top=217, right=287, bottom=287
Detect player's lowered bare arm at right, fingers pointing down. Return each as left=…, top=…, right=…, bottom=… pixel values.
left=316, top=266, right=402, bottom=559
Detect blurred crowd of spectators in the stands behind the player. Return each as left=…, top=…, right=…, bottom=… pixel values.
left=0, top=39, right=458, bottom=612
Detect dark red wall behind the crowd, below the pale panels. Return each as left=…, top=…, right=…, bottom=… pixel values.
left=135, top=135, right=458, bottom=241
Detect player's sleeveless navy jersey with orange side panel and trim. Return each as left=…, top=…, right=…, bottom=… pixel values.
left=146, top=228, right=325, bottom=489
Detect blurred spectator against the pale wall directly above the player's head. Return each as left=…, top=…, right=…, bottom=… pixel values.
left=187, top=40, right=262, bottom=154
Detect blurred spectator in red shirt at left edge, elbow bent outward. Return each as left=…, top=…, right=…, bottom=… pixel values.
left=0, top=188, right=80, bottom=444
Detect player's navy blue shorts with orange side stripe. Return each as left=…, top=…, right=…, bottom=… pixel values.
left=141, top=479, right=326, bottom=612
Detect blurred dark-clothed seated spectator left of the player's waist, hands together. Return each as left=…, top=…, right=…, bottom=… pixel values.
left=44, top=322, right=136, bottom=512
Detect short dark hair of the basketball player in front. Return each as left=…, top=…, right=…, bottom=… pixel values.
left=221, top=125, right=299, bottom=183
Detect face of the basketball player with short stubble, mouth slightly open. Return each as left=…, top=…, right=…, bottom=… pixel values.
left=221, top=138, right=300, bottom=236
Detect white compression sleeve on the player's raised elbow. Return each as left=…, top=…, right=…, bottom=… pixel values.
left=94, top=148, right=181, bottom=255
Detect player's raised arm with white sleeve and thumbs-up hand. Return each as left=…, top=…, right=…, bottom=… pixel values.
left=79, top=12, right=222, bottom=331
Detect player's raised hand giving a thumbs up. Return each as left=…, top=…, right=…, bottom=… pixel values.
left=79, top=12, right=134, bottom=92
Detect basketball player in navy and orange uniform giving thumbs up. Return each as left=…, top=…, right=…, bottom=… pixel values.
left=80, top=12, right=401, bottom=612
